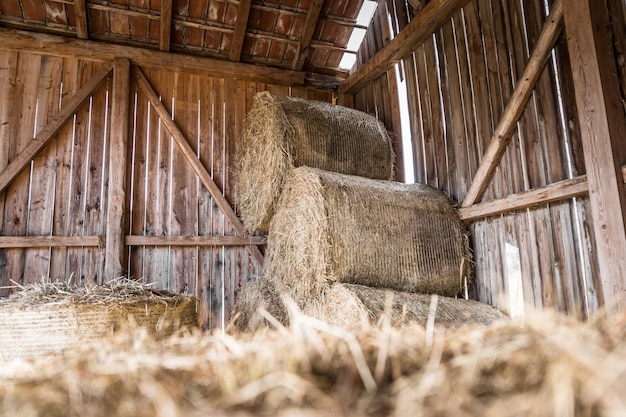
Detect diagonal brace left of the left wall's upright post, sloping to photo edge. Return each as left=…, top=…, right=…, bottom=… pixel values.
left=0, top=64, right=113, bottom=192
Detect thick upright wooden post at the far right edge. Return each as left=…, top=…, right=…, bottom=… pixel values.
left=563, top=0, right=626, bottom=311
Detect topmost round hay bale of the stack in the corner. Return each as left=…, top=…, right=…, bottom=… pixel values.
left=236, top=92, right=395, bottom=232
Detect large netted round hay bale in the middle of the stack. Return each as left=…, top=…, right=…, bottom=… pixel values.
left=265, top=167, right=470, bottom=308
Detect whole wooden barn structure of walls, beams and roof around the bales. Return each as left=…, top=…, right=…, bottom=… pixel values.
left=0, top=0, right=626, bottom=328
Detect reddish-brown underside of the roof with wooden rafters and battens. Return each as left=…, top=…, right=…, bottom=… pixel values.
left=0, top=0, right=370, bottom=78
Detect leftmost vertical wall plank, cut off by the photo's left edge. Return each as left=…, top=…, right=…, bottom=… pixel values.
left=0, top=50, right=18, bottom=297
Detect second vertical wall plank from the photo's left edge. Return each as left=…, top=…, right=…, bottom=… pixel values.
left=1, top=53, right=41, bottom=283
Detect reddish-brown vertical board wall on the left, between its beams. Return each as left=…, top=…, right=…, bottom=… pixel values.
left=0, top=49, right=332, bottom=327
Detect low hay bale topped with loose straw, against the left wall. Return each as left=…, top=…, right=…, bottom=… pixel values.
left=0, top=280, right=197, bottom=360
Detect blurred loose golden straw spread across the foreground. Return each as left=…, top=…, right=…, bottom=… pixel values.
left=0, top=308, right=626, bottom=417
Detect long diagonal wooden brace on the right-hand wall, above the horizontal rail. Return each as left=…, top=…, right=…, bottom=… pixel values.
left=463, top=0, right=563, bottom=207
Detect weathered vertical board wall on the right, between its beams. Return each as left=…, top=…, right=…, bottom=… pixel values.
left=354, top=0, right=626, bottom=318
